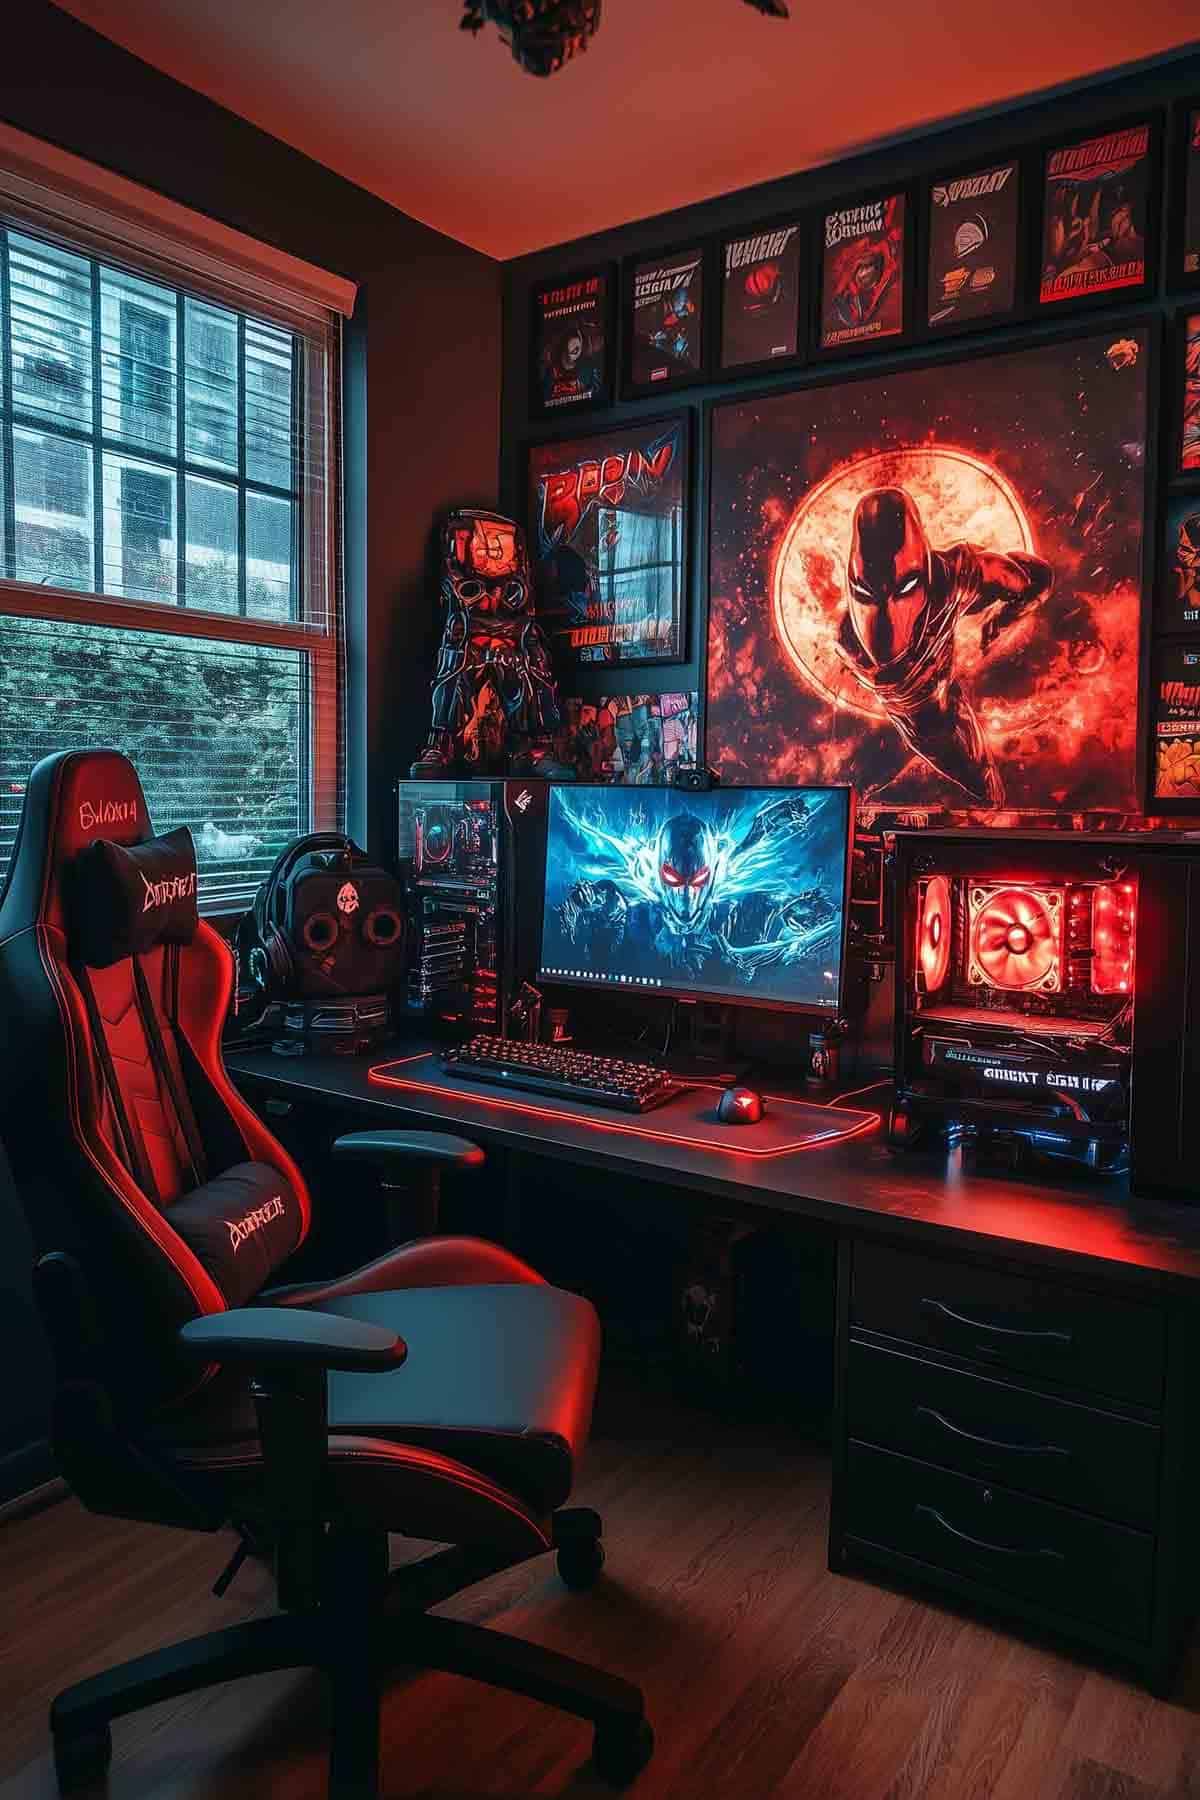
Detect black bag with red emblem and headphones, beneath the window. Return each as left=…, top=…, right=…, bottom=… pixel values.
left=237, top=832, right=408, bottom=1055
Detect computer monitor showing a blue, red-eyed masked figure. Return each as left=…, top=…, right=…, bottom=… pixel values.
left=540, top=787, right=853, bottom=1015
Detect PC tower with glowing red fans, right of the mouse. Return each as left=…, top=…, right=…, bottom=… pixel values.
left=891, top=830, right=1200, bottom=1199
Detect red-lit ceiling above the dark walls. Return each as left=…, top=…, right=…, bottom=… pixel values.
left=59, top=0, right=1195, bottom=257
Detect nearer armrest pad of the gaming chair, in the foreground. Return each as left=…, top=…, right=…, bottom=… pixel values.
left=180, top=1307, right=408, bottom=1373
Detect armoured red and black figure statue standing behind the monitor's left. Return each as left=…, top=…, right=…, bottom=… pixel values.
left=410, top=506, right=574, bottom=781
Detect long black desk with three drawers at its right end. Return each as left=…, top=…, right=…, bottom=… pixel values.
left=228, top=1044, right=1200, bottom=1687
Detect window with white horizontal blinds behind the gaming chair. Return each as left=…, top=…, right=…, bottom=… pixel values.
left=0, top=206, right=344, bottom=911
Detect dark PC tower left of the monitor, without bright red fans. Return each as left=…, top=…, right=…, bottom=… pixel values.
left=396, top=778, right=547, bottom=1031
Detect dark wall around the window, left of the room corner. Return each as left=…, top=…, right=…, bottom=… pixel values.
left=0, top=0, right=500, bottom=851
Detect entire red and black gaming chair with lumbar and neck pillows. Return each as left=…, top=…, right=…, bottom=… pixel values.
left=0, top=751, right=653, bottom=1800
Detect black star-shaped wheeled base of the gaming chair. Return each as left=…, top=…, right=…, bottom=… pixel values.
left=50, top=1508, right=653, bottom=1800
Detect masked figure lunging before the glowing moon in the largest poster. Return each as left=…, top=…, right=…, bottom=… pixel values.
left=837, top=488, right=1054, bottom=806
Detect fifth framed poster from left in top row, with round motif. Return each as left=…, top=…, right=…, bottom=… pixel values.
left=927, top=158, right=1020, bottom=329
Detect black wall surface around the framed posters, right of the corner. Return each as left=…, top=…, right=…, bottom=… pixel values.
left=500, top=52, right=1200, bottom=752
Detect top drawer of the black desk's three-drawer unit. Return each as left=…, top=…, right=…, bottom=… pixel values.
left=851, top=1244, right=1164, bottom=1406
